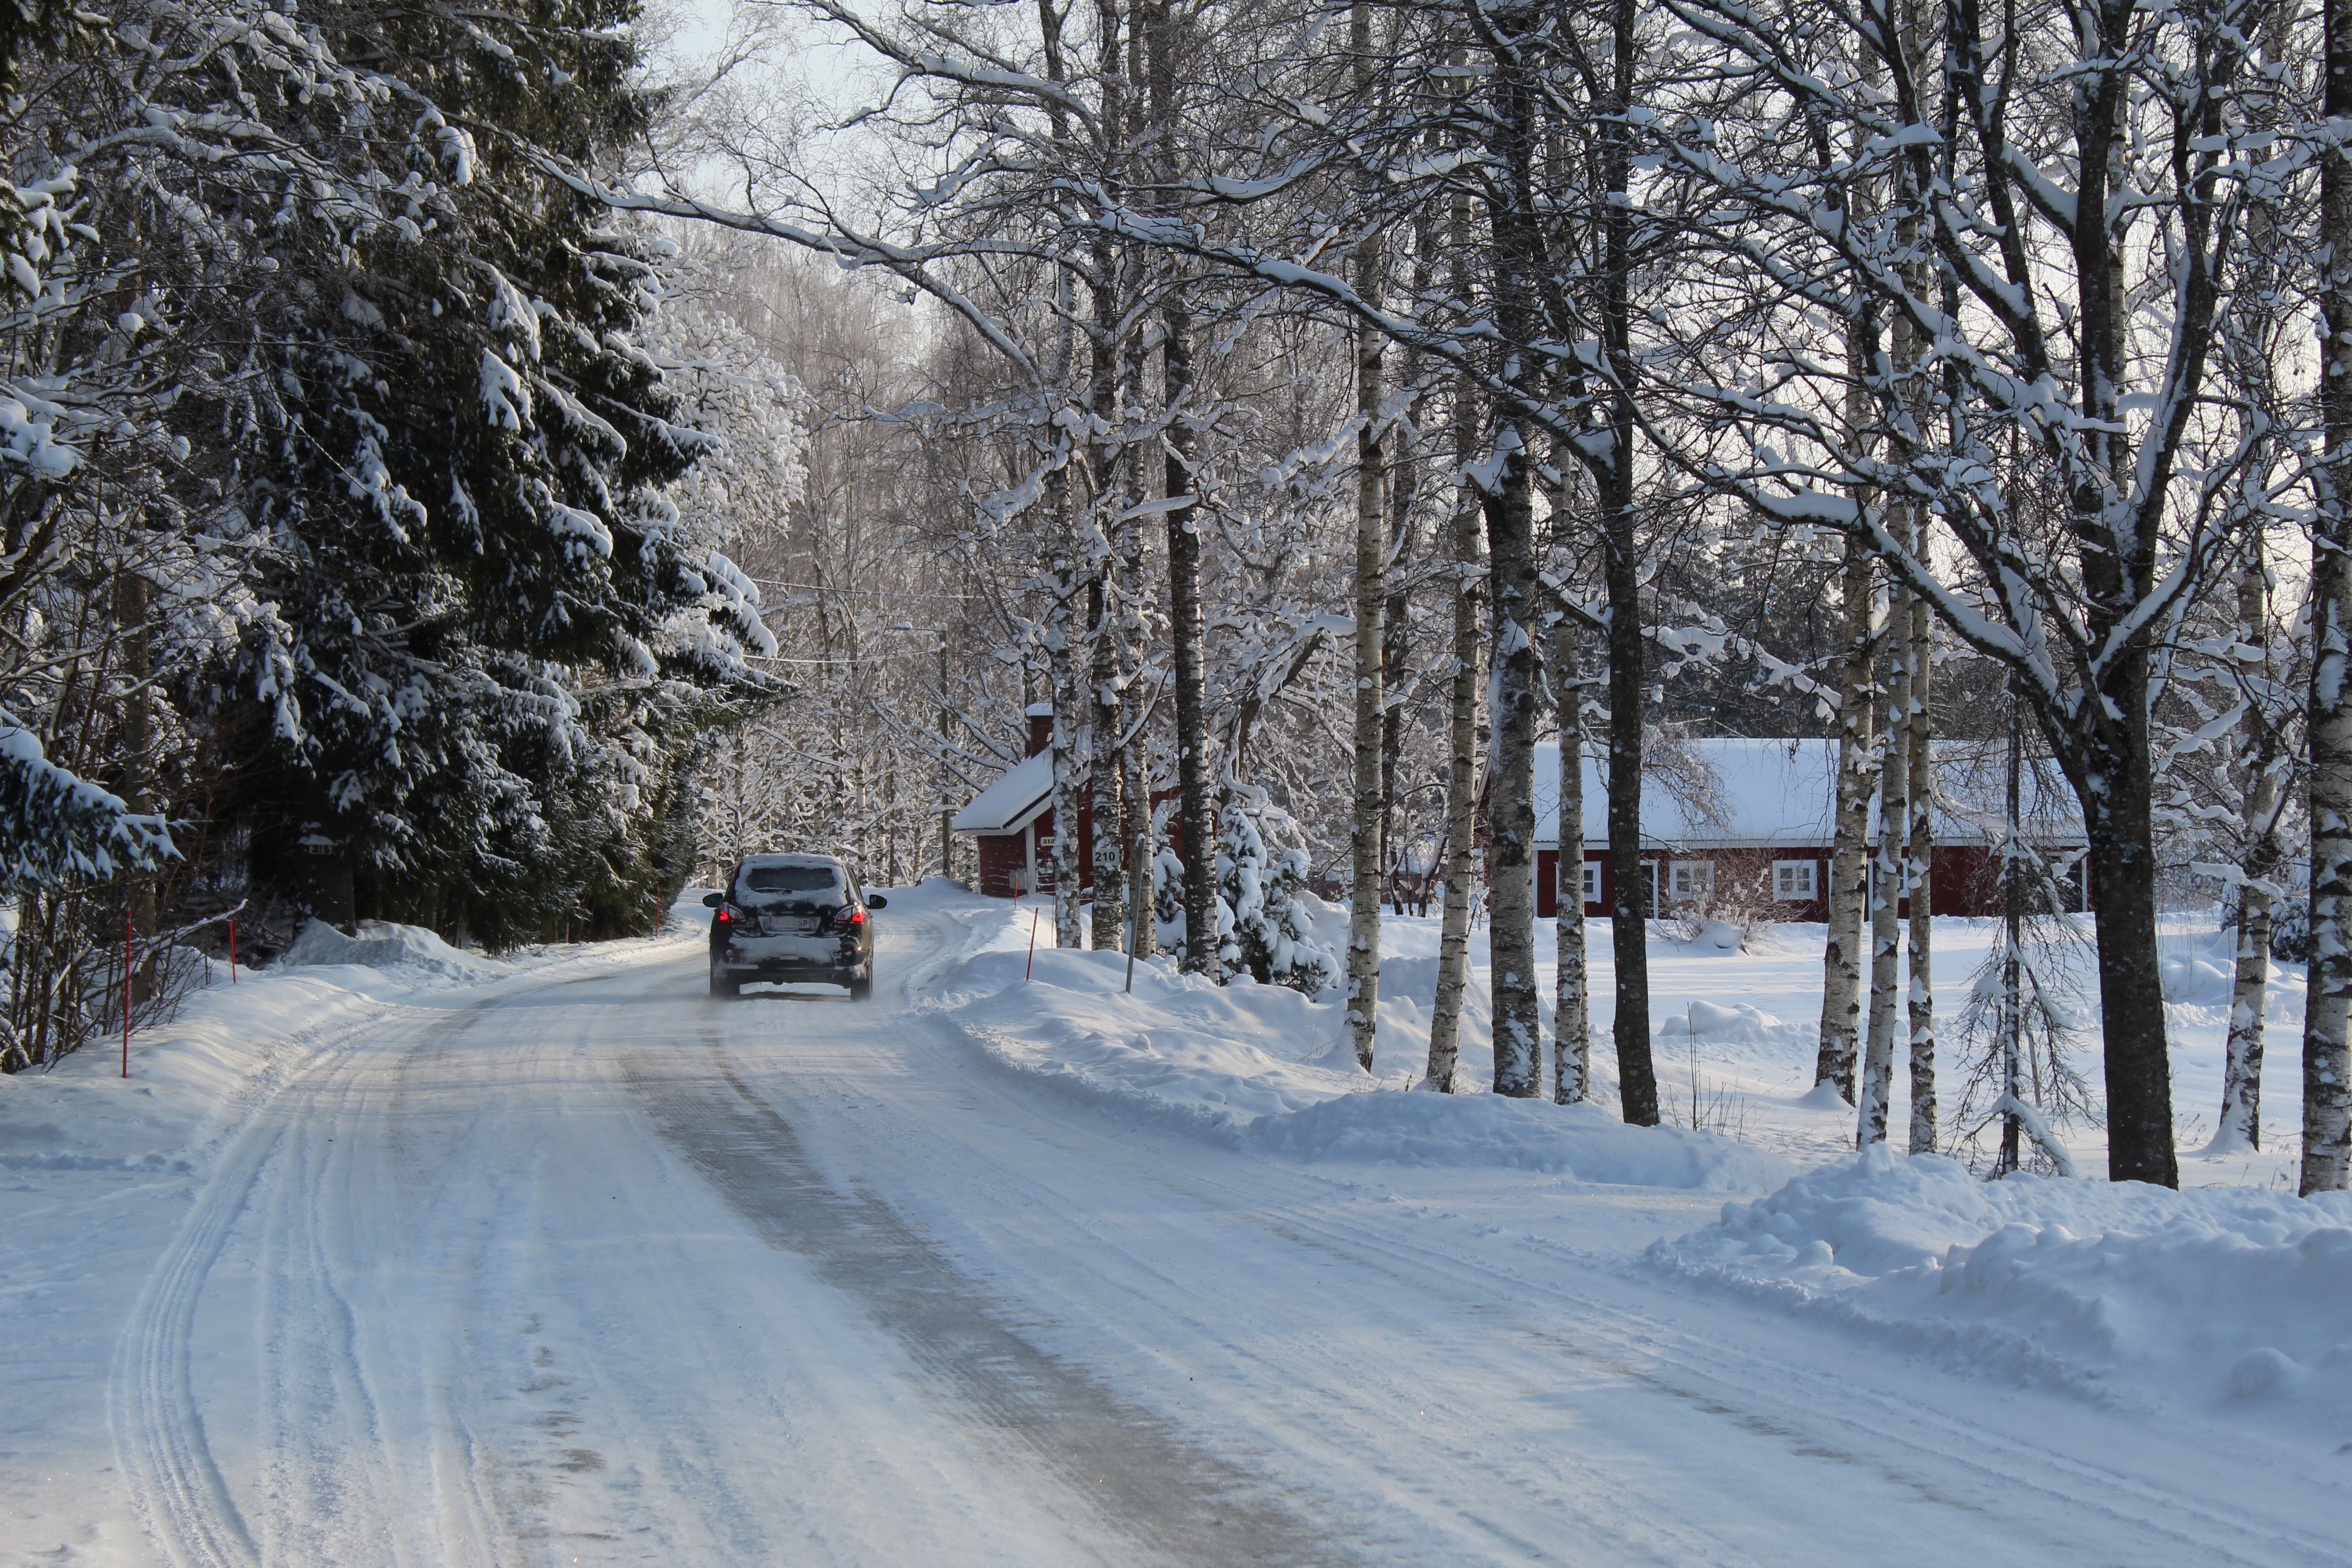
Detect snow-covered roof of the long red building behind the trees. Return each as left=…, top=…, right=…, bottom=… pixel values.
left=1536, top=738, right=2082, bottom=848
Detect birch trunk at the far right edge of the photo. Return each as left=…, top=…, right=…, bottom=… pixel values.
left=2300, top=0, right=2352, bottom=1194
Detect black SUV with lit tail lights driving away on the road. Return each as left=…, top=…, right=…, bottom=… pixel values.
left=703, top=856, right=887, bottom=1001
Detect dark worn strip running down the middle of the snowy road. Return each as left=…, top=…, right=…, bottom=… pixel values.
left=618, top=1044, right=1352, bottom=1568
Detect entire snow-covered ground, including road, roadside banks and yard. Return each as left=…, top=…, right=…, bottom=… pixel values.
left=0, top=884, right=2352, bottom=1568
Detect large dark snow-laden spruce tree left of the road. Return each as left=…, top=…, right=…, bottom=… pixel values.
left=80, top=0, right=790, bottom=931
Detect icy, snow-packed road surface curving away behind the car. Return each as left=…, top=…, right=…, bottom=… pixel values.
left=32, top=907, right=2352, bottom=1568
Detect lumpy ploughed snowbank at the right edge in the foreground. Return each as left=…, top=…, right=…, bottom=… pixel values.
left=1649, top=1145, right=2352, bottom=1436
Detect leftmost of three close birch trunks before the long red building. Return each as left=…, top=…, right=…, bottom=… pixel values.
left=1813, top=534, right=1877, bottom=1105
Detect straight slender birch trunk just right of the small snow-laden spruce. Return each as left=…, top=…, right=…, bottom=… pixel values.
left=1348, top=0, right=1388, bottom=1072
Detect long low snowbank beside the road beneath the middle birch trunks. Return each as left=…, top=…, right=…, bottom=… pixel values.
left=922, top=933, right=1790, bottom=1192
